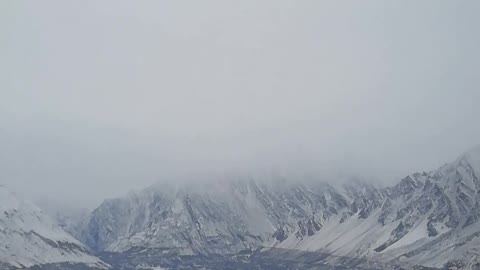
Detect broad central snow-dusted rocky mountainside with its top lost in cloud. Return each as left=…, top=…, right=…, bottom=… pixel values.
left=81, top=179, right=360, bottom=254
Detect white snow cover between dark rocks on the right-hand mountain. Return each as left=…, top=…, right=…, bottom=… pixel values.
left=275, top=147, right=480, bottom=269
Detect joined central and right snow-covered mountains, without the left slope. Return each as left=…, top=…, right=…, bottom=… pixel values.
left=76, top=148, right=480, bottom=268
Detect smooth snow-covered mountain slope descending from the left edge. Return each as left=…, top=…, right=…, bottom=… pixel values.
left=0, top=186, right=106, bottom=269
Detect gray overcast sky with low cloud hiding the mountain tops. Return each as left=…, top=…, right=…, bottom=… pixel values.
left=0, top=0, right=480, bottom=207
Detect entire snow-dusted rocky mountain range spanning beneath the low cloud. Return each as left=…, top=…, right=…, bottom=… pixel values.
left=0, top=147, right=480, bottom=269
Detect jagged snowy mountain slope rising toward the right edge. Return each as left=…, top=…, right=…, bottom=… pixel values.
left=278, top=148, right=480, bottom=268
